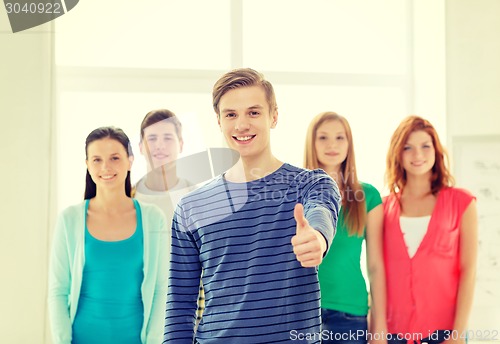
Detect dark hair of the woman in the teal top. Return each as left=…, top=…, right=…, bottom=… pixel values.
left=83, top=127, right=134, bottom=199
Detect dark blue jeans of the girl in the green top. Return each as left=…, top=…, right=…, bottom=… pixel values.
left=321, top=308, right=368, bottom=344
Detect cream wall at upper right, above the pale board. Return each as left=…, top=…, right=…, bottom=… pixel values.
left=446, top=0, right=500, bottom=136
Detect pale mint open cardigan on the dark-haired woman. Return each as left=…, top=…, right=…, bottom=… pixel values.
left=48, top=202, right=170, bottom=344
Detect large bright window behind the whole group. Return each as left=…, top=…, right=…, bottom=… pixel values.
left=55, top=0, right=445, bottom=209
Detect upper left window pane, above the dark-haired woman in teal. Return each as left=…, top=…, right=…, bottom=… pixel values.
left=55, top=0, right=231, bottom=69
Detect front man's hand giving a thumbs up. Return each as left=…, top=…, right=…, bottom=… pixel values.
left=292, top=203, right=326, bottom=268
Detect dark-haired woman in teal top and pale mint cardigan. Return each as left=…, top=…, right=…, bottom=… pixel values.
left=48, top=127, right=169, bottom=344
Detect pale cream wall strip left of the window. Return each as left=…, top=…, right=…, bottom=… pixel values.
left=0, top=12, right=54, bottom=344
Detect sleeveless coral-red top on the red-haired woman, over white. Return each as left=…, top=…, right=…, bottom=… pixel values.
left=383, top=188, right=474, bottom=338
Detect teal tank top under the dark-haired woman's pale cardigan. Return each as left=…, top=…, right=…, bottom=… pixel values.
left=72, top=199, right=144, bottom=344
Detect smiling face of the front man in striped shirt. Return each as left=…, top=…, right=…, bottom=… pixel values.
left=218, top=86, right=278, bottom=159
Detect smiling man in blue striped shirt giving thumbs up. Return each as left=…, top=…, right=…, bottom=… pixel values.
left=164, top=68, right=340, bottom=344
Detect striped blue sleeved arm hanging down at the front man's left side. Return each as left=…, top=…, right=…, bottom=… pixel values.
left=163, top=207, right=201, bottom=344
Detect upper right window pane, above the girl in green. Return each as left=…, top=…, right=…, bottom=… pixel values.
left=243, top=0, right=411, bottom=74
